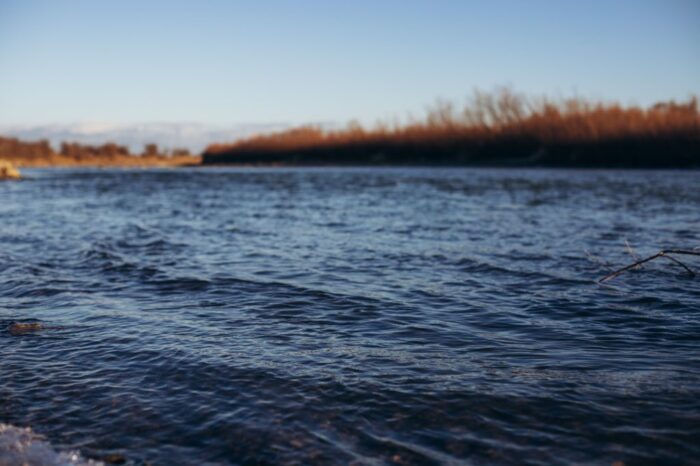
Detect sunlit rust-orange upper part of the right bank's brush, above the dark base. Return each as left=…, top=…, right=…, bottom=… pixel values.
left=205, top=88, right=700, bottom=166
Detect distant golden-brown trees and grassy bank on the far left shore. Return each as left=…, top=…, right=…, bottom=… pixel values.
left=0, top=137, right=200, bottom=167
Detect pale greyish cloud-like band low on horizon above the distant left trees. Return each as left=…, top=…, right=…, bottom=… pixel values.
left=0, top=123, right=290, bottom=153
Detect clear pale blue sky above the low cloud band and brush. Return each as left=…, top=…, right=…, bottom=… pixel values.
left=0, top=0, right=700, bottom=125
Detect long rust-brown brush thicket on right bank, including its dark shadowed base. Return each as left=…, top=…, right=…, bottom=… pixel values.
left=203, top=89, right=700, bottom=166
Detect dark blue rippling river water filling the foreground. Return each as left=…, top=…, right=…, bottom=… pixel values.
left=0, top=169, right=700, bottom=465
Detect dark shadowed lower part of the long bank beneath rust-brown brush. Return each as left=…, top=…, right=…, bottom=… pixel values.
left=202, top=139, right=700, bottom=168
